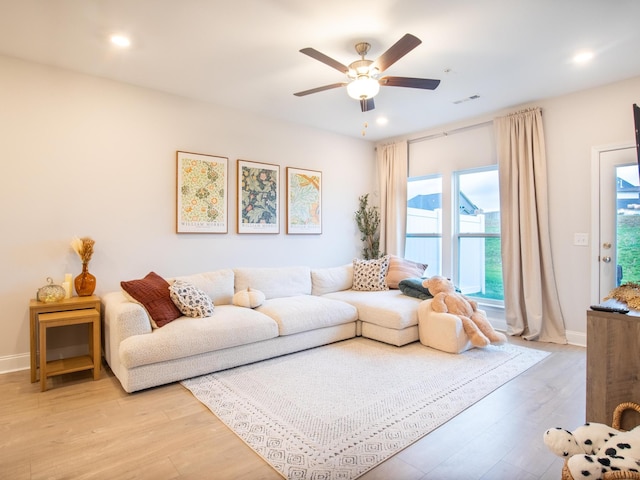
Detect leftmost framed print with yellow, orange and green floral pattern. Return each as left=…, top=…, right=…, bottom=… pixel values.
left=176, top=151, right=229, bottom=233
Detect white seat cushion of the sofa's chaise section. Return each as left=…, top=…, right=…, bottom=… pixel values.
left=322, top=290, right=422, bottom=330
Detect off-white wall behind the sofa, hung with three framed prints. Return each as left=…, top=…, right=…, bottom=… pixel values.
left=0, top=57, right=375, bottom=371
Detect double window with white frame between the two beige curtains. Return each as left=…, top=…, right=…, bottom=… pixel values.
left=405, top=165, right=504, bottom=305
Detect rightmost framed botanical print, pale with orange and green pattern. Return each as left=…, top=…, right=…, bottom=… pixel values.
left=287, top=167, right=322, bottom=234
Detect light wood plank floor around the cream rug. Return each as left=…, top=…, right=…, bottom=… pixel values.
left=0, top=339, right=586, bottom=480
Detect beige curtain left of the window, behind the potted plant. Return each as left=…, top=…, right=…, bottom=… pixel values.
left=376, top=142, right=408, bottom=257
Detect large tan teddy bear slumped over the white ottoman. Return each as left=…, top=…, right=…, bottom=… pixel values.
left=422, top=275, right=507, bottom=347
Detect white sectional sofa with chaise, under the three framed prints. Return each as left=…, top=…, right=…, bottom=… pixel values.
left=103, top=265, right=468, bottom=392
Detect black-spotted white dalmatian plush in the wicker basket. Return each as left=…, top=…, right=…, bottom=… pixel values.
left=544, top=423, right=640, bottom=480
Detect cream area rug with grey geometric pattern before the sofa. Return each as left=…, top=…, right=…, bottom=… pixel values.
left=182, top=338, right=548, bottom=480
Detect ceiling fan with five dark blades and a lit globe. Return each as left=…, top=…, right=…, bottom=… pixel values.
left=294, top=33, right=440, bottom=112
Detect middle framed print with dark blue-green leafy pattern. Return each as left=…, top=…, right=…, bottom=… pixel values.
left=237, top=160, right=280, bottom=233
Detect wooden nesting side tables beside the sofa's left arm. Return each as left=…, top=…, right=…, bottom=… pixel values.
left=29, top=295, right=101, bottom=390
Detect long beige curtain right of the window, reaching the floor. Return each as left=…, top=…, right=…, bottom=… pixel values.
left=494, top=108, right=567, bottom=343
